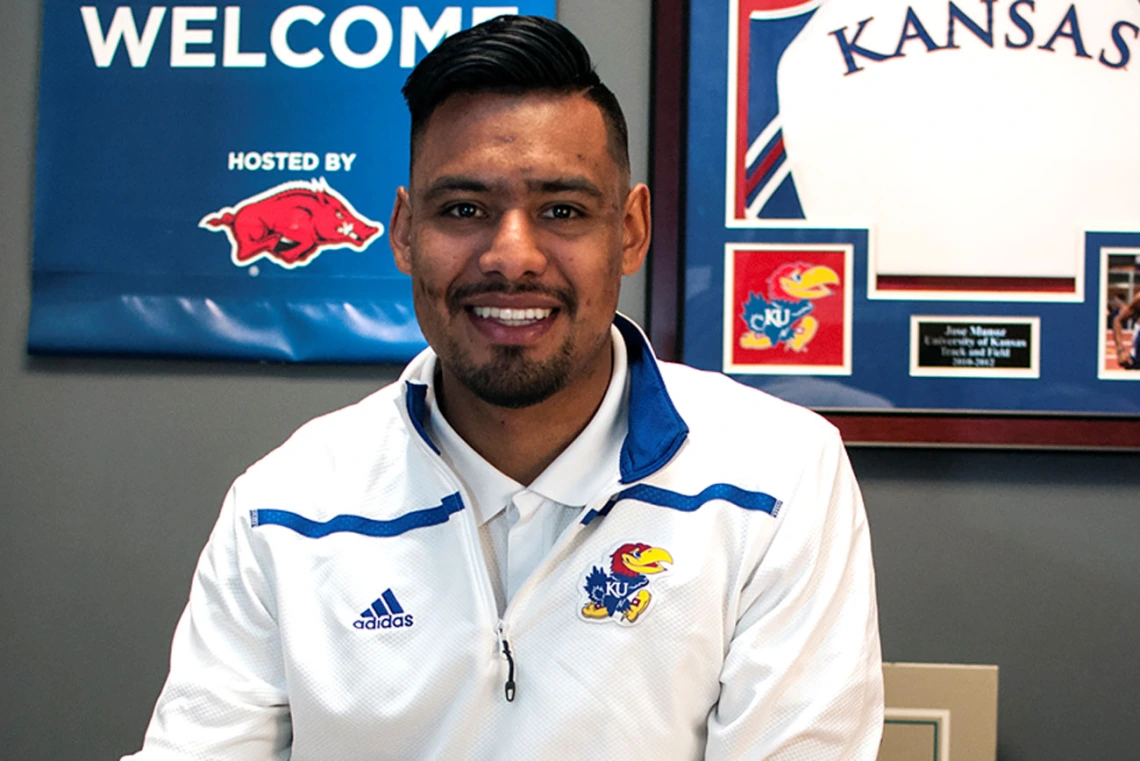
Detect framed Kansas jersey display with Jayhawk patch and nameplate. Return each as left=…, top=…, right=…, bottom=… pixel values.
left=650, top=0, right=1140, bottom=449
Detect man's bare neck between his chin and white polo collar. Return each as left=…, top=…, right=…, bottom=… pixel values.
left=435, top=342, right=613, bottom=485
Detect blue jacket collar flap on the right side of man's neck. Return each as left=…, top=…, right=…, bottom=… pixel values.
left=613, top=314, right=689, bottom=483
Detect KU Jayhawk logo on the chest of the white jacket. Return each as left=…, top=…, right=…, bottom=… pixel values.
left=580, top=543, right=673, bottom=625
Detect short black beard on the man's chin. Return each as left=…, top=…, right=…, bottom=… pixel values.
left=447, top=336, right=573, bottom=409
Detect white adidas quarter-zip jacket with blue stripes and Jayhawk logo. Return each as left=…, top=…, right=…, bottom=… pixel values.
left=127, top=317, right=882, bottom=761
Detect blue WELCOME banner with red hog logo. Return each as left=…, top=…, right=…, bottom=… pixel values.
left=29, top=0, right=554, bottom=362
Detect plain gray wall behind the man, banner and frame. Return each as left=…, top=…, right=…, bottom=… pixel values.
left=0, top=0, right=1140, bottom=761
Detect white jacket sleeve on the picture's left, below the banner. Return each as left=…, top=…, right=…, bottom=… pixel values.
left=123, top=480, right=292, bottom=761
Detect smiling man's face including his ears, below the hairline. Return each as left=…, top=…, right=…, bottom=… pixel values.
left=389, top=93, right=650, bottom=408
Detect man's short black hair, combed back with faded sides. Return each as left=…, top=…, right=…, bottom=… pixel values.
left=404, top=16, right=629, bottom=175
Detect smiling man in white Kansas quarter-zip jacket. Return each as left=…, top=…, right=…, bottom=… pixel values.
left=127, top=17, right=882, bottom=761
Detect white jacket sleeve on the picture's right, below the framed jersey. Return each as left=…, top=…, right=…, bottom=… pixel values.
left=706, top=429, right=884, bottom=761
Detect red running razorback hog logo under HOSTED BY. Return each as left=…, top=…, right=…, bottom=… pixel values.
left=198, top=178, right=384, bottom=269
